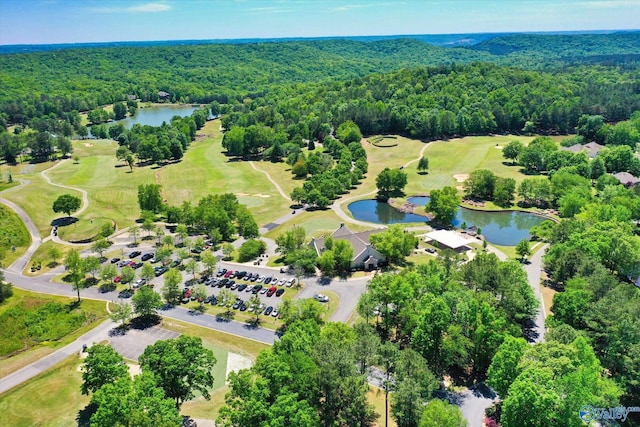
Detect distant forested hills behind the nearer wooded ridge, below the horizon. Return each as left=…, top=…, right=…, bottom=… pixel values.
left=0, top=33, right=640, bottom=127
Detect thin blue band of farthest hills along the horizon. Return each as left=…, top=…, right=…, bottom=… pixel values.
left=0, top=28, right=640, bottom=49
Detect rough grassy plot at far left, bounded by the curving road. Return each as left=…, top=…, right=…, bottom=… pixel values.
left=0, top=288, right=107, bottom=376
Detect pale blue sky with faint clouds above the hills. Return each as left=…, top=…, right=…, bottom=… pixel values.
left=0, top=0, right=640, bottom=45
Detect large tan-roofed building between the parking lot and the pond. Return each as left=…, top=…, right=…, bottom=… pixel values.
left=309, top=223, right=387, bottom=271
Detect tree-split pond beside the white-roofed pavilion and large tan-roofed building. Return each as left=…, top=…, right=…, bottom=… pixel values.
left=348, top=197, right=547, bottom=246
